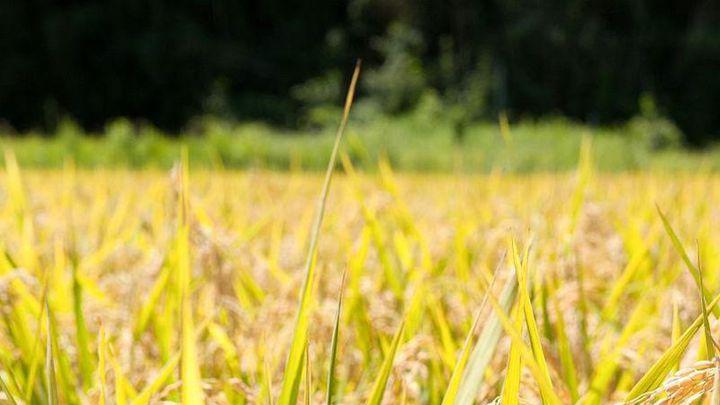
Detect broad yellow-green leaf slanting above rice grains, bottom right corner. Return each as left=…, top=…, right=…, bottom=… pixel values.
left=626, top=295, right=720, bottom=401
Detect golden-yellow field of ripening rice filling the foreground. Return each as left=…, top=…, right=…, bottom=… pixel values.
left=0, top=144, right=720, bottom=404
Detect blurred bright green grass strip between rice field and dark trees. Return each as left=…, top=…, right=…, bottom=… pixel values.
left=7, top=113, right=720, bottom=173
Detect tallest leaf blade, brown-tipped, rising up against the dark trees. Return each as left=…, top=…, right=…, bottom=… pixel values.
left=278, top=61, right=360, bottom=405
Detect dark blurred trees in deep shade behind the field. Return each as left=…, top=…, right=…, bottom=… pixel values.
left=0, top=0, right=720, bottom=144
